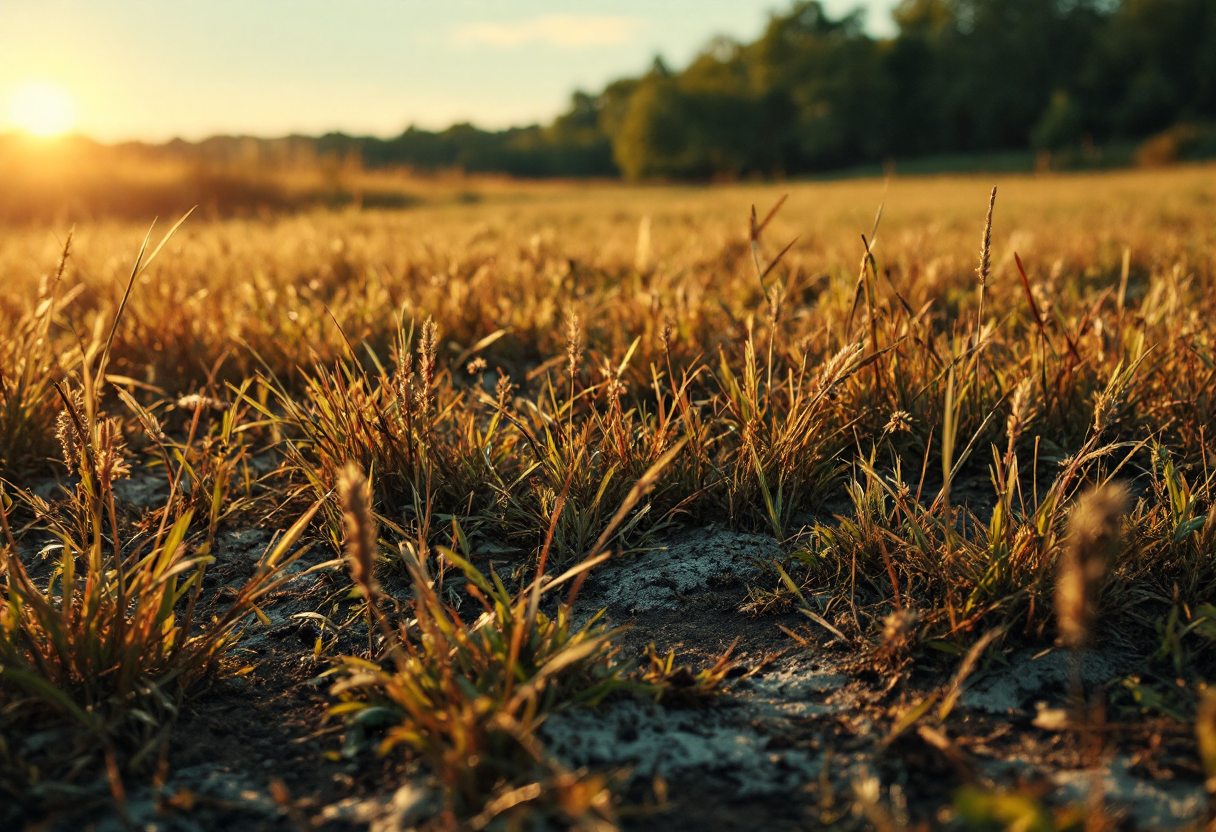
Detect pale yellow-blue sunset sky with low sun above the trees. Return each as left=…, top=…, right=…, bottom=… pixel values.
left=0, top=0, right=895, bottom=141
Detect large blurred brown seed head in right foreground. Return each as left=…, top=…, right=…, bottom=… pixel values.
left=1055, top=484, right=1131, bottom=650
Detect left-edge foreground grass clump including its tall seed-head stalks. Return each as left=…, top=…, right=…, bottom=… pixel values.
left=0, top=212, right=315, bottom=802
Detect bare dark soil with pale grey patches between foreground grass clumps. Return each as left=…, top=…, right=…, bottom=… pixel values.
left=14, top=528, right=1210, bottom=832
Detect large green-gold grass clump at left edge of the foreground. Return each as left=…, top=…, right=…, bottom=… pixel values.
left=0, top=428, right=311, bottom=798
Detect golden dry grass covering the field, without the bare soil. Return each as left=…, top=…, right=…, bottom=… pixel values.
left=0, top=160, right=1216, bottom=826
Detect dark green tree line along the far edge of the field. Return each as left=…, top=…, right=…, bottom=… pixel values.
left=214, top=0, right=1216, bottom=180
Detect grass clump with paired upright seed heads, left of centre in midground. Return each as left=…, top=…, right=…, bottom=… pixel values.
left=257, top=320, right=516, bottom=552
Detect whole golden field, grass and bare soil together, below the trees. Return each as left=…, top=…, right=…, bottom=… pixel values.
left=0, top=167, right=1216, bottom=831
